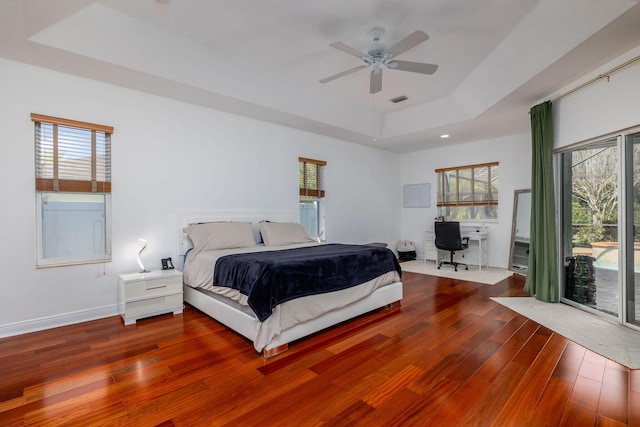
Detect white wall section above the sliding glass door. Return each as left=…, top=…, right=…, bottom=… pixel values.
left=550, top=46, right=640, bottom=148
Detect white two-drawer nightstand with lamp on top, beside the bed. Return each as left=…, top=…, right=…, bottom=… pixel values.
left=118, top=270, right=183, bottom=325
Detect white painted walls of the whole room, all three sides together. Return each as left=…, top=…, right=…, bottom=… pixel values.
left=7, top=41, right=640, bottom=336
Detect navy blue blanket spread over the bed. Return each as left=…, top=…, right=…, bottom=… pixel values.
left=218, top=244, right=402, bottom=322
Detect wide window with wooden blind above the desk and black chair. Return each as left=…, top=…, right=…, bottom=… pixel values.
left=436, top=162, right=498, bottom=220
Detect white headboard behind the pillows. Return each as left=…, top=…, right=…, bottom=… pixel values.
left=175, top=209, right=300, bottom=257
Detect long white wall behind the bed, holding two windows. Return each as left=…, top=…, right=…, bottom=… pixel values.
left=0, top=59, right=400, bottom=336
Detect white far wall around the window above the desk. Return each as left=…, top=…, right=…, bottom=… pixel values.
left=400, top=134, right=531, bottom=268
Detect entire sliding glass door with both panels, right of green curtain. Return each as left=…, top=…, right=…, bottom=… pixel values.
left=559, top=132, right=640, bottom=326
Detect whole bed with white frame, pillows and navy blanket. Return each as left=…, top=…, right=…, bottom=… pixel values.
left=176, top=211, right=402, bottom=358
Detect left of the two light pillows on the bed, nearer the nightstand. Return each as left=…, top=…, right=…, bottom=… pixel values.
left=182, top=222, right=256, bottom=252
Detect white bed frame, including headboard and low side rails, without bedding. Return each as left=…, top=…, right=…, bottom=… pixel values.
left=176, top=211, right=402, bottom=358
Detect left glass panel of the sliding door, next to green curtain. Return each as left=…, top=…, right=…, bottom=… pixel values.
left=562, top=139, right=620, bottom=316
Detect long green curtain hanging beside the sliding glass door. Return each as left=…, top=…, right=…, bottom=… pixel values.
left=524, top=101, right=560, bottom=302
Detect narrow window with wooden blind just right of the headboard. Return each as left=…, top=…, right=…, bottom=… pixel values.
left=298, top=157, right=327, bottom=239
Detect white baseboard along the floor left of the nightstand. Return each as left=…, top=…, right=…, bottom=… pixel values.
left=0, top=304, right=120, bottom=338
